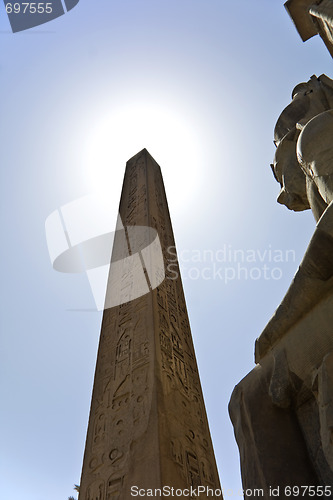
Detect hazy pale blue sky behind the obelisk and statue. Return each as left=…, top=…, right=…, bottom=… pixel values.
left=0, top=0, right=332, bottom=500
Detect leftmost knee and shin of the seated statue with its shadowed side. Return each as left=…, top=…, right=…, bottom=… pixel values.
left=229, top=356, right=319, bottom=499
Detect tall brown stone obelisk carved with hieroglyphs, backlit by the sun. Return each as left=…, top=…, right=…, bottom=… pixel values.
left=79, top=149, right=222, bottom=500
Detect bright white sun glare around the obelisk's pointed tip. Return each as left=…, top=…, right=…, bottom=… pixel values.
left=84, top=104, right=201, bottom=213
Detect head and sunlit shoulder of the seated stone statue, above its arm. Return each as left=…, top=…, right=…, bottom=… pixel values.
left=272, top=75, right=333, bottom=221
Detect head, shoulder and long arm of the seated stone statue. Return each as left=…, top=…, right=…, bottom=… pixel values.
left=256, top=75, right=333, bottom=361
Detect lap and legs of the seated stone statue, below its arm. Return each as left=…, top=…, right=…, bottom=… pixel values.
left=229, top=294, right=333, bottom=498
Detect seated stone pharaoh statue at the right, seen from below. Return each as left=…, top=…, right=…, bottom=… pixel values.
left=229, top=75, right=333, bottom=499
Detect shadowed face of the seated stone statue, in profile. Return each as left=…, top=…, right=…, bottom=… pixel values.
left=271, top=134, right=310, bottom=212
